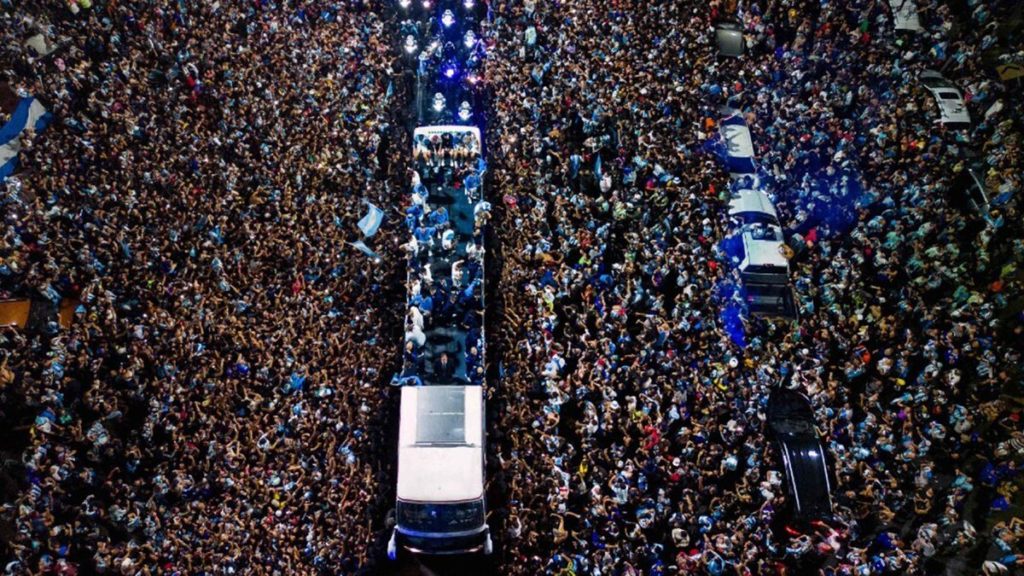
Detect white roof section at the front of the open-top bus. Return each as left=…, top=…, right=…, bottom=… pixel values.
left=397, top=385, right=483, bottom=502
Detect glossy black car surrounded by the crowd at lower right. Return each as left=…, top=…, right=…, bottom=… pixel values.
left=768, top=388, right=831, bottom=521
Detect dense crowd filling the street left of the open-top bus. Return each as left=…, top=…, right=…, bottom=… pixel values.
left=0, top=0, right=409, bottom=574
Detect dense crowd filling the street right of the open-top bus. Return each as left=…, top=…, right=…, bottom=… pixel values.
left=487, top=0, right=1024, bottom=575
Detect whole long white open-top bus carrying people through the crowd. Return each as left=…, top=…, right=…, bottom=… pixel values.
left=388, top=125, right=493, bottom=559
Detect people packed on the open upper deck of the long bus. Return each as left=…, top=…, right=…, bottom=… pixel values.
left=398, top=129, right=490, bottom=385
